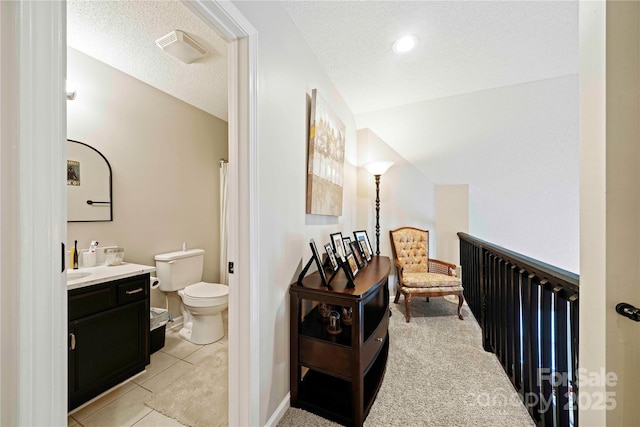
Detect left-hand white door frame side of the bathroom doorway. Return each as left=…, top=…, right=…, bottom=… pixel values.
left=0, top=2, right=67, bottom=425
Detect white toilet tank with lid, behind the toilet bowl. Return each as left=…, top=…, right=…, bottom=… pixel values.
left=155, top=249, right=204, bottom=292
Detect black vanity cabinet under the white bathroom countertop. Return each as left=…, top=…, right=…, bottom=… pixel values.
left=68, top=273, right=149, bottom=410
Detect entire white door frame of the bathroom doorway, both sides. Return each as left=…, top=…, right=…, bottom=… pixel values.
left=0, top=0, right=259, bottom=425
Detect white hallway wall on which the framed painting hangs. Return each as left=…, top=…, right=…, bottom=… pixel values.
left=234, top=1, right=357, bottom=425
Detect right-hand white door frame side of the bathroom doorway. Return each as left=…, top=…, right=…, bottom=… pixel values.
left=183, top=0, right=260, bottom=426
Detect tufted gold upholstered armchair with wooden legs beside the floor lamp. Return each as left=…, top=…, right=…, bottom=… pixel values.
left=389, top=227, right=464, bottom=323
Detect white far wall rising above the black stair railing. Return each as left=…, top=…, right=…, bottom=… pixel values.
left=357, top=75, right=579, bottom=272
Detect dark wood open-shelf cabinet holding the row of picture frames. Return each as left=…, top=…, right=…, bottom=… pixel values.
left=289, top=256, right=391, bottom=426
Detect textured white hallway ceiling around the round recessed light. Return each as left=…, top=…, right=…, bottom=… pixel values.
left=283, top=1, right=578, bottom=115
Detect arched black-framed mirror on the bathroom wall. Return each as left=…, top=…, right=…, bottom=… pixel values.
left=67, top=139, right=113, bottom=222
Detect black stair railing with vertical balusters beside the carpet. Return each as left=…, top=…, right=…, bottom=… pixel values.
left=458, top=233, right=579, bottom=427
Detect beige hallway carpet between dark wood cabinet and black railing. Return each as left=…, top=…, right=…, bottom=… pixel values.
left=278, top=298, right=535, bottom=427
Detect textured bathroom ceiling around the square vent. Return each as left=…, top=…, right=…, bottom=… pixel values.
left=67, top=0, right=228, bottom=120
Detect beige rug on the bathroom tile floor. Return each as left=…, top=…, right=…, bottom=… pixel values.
left=144, top=346, right=229, bottom=427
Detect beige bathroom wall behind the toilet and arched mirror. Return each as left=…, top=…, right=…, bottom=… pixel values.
left=67, top=48, right=228, bottom=316
